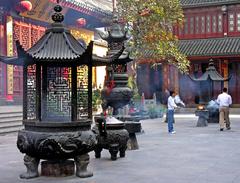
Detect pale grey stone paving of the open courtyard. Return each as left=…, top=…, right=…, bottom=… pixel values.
left=0, top=115, right=240, bottom=183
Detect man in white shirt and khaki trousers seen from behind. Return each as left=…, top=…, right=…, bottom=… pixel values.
left=217, top=88, right=232, bottom=131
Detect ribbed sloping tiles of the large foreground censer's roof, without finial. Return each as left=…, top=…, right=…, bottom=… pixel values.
left=27, top=25, right=86, bottom=61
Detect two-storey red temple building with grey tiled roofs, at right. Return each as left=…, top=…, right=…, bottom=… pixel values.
left=138, top=0, right=240, bottom=106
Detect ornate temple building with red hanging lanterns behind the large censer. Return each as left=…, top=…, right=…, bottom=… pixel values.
left=0, top=0, right=112, bottom=105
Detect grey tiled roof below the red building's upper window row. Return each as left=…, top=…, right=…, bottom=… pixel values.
left=179, top=37, right=240, bottom=56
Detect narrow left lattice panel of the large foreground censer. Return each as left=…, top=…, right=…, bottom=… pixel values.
left=27, top=65, right=36, bottom=119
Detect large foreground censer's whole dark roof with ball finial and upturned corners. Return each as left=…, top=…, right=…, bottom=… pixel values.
left=0, top=5, right=93, bottom=65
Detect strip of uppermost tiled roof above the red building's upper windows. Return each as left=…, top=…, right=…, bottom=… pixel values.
left=180, top=0, right=240, bottom=7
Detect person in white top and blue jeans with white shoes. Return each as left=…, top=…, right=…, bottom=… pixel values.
left=167, top=91, right=177, bottom=134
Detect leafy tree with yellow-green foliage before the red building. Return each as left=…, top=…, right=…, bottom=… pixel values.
left=117, top=0, right=189, bottom=72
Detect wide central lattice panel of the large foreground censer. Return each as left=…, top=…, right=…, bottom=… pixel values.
left=44, top=67, right=71, bottom=121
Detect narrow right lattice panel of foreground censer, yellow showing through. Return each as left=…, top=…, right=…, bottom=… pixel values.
left=77, top=66, right=88, bottom=119
